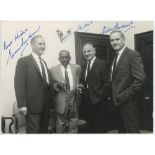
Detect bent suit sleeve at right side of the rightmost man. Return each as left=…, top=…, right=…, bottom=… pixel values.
left=129, top=52, right=145, bottom=95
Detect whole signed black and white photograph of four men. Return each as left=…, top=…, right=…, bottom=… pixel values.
left=1, top=20, right=153, bottom=135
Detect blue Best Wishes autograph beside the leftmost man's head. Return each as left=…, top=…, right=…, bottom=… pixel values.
left=3, top=26, right=40, bottom=64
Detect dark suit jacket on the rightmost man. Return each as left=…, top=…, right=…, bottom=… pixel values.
left=112, top=48, right=145, bottom=105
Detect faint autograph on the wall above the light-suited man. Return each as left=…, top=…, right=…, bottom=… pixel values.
left=56, top=21, right=93, bottom=42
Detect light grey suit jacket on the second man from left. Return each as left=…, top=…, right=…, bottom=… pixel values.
left=50, top=64, right=81, bottom=114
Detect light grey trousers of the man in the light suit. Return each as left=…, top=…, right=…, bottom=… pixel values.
left=56, top=91, right=78, bottom=133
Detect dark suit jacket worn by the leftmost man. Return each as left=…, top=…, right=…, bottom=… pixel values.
left=14, top=55, right=52, bottom=113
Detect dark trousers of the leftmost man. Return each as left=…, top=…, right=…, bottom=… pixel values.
left=26, top=87, right=52, bottom=133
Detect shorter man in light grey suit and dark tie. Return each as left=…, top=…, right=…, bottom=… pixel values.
left=50, top=50, right=81, bottom=133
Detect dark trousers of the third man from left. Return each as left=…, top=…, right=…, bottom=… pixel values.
left=79, top=91, right=107, bottom=133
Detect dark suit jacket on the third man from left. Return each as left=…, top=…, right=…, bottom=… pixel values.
left=81, top=58, right=108, bottom=104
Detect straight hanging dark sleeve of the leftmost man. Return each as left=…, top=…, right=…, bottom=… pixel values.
left=14, top=59, right=27, bottom=108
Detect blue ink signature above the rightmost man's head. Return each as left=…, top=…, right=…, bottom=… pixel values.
left=102, top=21, right=135, bottom=34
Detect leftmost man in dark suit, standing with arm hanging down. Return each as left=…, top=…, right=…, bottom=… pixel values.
left=14, top=35, right=52, bottom=133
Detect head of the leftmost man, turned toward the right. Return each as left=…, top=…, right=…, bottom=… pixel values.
left=32, top=37, right=45, bottom=56
